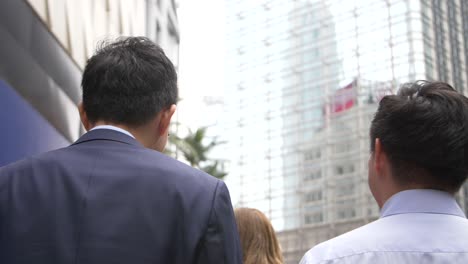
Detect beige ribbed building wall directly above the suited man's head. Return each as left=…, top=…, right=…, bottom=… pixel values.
left=28, top=0, right=146, bottom=68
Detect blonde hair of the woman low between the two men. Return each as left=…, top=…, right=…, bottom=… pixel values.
left=235, top=208, right=283, bottom=264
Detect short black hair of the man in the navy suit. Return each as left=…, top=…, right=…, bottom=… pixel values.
left=81, top=37, right=178, bottom=127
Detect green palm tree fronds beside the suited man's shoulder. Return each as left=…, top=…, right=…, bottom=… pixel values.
left=169, top=127, right=227, bottom=179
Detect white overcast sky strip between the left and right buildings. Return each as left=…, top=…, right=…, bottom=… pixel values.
left=177, top=0, right=225, bottom=128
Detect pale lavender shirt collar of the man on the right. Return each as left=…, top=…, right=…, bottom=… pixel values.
left=380, top=189, right=466, bottom=218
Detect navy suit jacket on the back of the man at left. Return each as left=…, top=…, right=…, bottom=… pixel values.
left=0, top=130, right=241, bottom=263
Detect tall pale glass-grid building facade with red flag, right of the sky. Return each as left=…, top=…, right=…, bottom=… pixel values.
left=221, top=0, right=468, bottom=263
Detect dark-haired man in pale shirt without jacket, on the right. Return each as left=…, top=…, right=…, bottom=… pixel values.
left=301, top=81, right=468, bottom=264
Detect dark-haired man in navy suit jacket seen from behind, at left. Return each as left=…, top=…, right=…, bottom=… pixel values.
left=0, top=38, right=242, bottom=264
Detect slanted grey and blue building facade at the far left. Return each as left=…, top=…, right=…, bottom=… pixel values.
left=0, top=1, right=82, bottom=166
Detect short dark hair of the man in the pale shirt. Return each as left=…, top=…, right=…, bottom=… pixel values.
left=370, top=81, right=468, bottom=192
